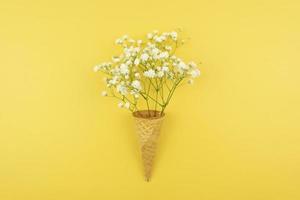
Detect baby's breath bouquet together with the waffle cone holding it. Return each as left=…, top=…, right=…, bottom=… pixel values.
left=94, top=31, right=200, bottom=181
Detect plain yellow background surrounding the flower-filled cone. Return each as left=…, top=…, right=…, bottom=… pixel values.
left=0, top=0, right=300, bottom=200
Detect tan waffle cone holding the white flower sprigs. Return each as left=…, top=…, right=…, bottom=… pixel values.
left=133, top=110, right=164, bottom=181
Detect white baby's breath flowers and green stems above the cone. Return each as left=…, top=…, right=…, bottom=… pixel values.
left=94, top=28, right=200, bottom=113
